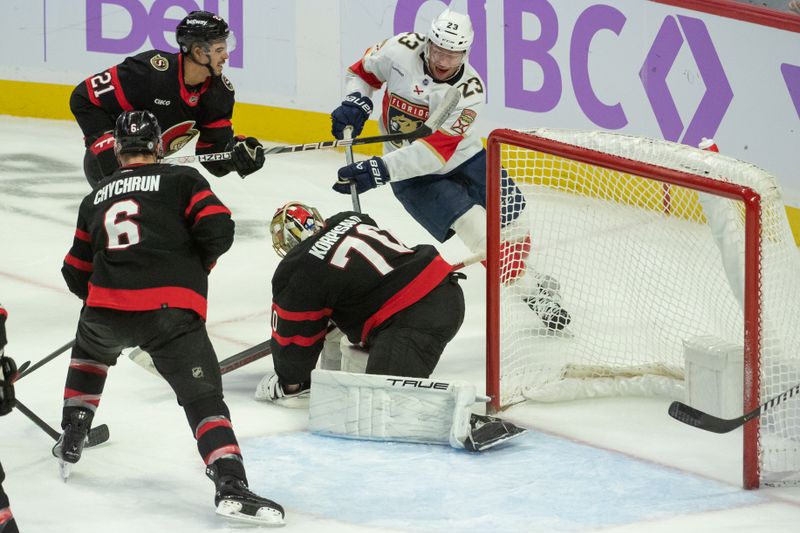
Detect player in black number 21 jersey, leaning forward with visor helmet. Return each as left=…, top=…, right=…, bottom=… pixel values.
left=69, top=11, right=264, bottom=185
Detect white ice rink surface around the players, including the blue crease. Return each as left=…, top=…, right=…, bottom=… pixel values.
left=0, top=117, right=800, bottom=533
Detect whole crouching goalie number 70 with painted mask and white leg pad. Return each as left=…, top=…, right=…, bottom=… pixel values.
left=256, top=202, right=523, bottom=450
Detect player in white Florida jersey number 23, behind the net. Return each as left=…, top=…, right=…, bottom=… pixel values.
left=331, top=9, right=570, bottom=330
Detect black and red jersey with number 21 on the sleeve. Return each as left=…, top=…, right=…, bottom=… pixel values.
left=71, top=50, right=234, bottom=174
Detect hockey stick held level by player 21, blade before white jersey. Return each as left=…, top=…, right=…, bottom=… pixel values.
left=161, top=87, right=461, bottom=164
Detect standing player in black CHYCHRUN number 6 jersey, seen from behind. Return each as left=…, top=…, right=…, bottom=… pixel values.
left=53, top=111, right=284, bottom=525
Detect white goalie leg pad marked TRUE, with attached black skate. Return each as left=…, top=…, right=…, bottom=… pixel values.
left=308, top=369, right=526, bottom=452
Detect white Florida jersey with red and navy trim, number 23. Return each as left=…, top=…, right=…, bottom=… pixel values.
left=345, top=33, right=486, bottom=181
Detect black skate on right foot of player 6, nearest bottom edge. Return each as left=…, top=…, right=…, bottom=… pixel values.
left=206, top=464, right=286, bottom=527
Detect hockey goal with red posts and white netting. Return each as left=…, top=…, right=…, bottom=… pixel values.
left=487, top=129, right=800, bottom=488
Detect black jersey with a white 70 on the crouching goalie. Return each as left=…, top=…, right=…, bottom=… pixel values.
left=270, top=211, right=452, bottom=374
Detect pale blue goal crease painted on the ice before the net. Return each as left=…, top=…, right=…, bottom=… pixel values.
left=241, top=431, right=766, bottom=532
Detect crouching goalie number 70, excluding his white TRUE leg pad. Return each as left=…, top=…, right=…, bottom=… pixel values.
left=256, top=202, right=464, bottom=400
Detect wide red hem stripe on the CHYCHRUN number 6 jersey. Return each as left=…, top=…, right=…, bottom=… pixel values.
left=86, top=283, right=208, bottom=320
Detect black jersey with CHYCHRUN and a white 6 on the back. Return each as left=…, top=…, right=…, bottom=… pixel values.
left=61, top=164, right=234, bottom=319
